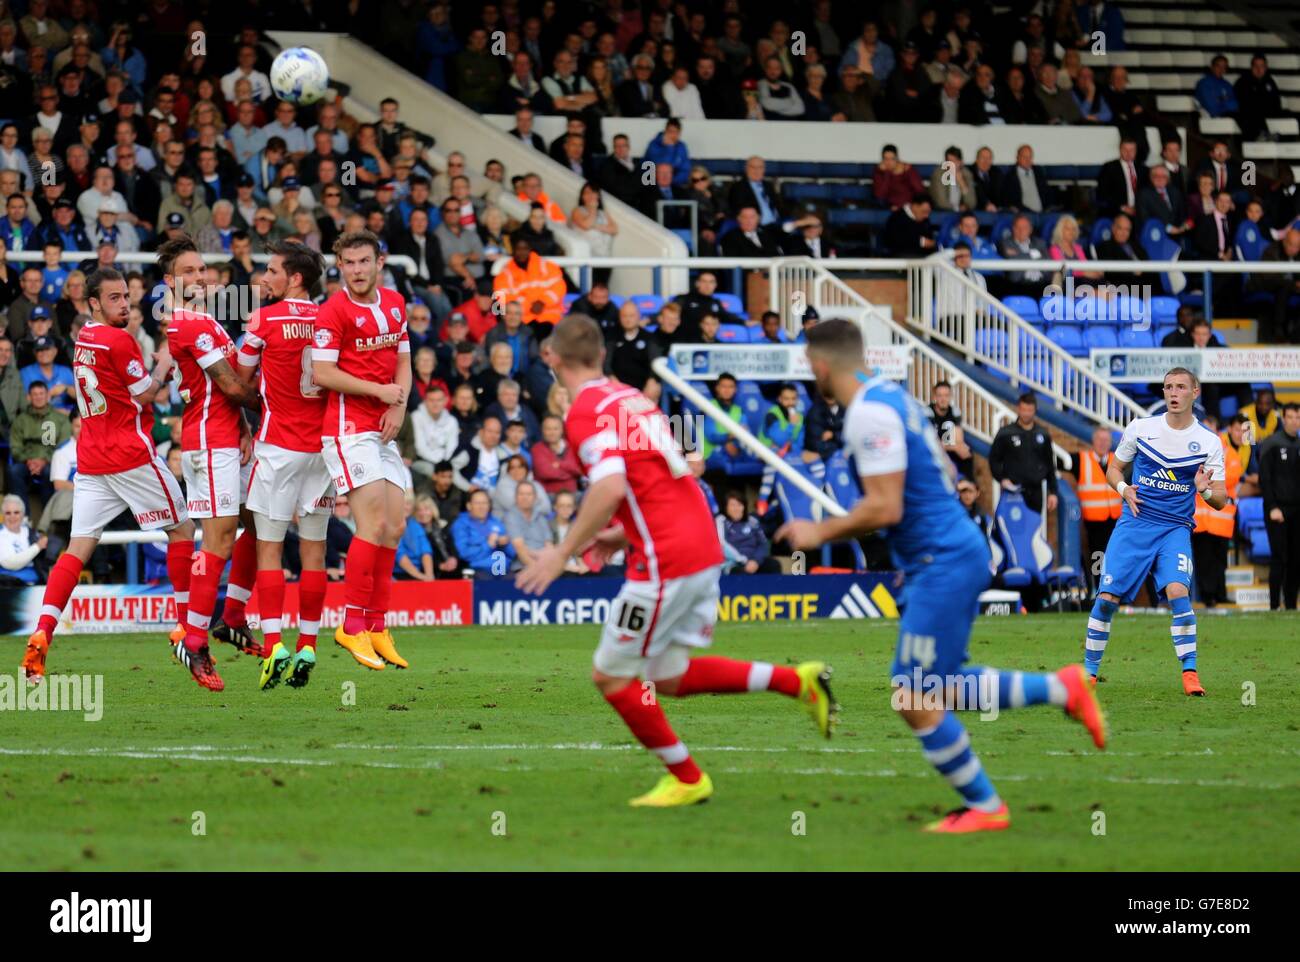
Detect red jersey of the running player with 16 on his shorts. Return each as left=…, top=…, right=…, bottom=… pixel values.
left=564, top=377, right=723, bottom=581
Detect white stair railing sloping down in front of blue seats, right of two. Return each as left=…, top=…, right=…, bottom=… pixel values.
left=907, top=257, right=1147, bottom=430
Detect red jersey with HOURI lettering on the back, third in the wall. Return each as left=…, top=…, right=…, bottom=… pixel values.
left=239, top=299, right=325, bottom=454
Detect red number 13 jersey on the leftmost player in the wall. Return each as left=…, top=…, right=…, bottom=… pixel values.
left=73, top=321, right=155, bottom=475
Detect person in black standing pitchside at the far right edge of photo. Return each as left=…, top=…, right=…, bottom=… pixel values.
left=1258, top=404, right=1300, bottom=611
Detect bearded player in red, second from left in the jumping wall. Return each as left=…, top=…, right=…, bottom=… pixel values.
left=159, top=235, right=260, bottom=692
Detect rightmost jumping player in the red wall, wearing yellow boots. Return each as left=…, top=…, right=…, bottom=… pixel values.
left=312, top=230, right=411, bottom=671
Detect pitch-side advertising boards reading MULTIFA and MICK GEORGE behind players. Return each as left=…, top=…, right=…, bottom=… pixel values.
left=0, top=572, right=1019, bottom=634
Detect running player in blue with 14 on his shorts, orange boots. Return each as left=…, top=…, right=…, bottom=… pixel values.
left=776, top=320, right=1105, bottom=833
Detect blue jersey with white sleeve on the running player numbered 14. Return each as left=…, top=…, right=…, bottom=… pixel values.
left=844, top=377, right=988, bottom=573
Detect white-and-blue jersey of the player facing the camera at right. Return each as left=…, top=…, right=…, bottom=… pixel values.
left=1115, top=415, right=1226, bottom=528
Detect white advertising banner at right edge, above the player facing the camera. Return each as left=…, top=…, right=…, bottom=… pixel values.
left=1089, top=347, right=1300, bottom=384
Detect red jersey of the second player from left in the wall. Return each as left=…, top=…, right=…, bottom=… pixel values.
left=166, top=308, right=242, bottom=451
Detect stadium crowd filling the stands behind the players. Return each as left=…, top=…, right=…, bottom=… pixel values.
left=0, top=0, right=1300, bottom=613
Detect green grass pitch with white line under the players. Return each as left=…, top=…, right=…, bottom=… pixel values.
left=0, top=615, right=1300, bottom=870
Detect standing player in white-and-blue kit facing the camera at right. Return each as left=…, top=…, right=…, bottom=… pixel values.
left=1083, top=368, right=1232, bottom=697
